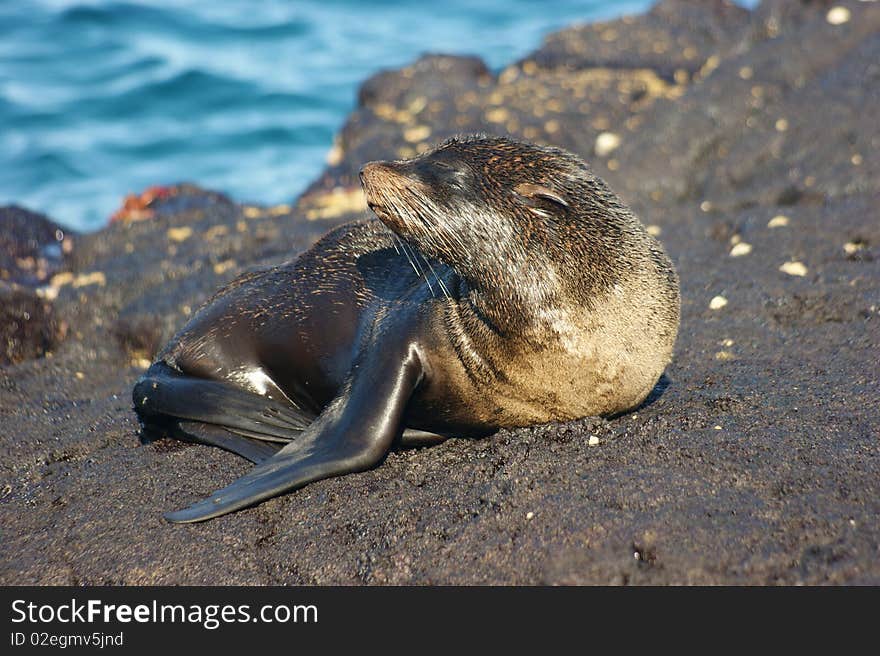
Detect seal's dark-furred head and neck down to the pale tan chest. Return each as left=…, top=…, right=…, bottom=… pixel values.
left=361, top=136, right=650, bottom=322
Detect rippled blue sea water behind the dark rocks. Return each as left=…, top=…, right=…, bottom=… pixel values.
left=0, top=0, right=664, bottom=230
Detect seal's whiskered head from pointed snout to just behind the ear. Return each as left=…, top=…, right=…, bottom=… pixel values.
left=361, top=136, right=588, bottom=258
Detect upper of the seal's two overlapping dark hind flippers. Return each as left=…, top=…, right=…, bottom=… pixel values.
left=132, top=362, right=314, bottom=442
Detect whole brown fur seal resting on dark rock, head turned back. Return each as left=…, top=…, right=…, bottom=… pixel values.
left=133, top=136, right=679, bottom=522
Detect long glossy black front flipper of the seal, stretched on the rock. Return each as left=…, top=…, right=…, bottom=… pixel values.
left=165, top=338, right=424, bottom=523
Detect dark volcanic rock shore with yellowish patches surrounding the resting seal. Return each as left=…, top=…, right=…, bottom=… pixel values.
left=0, top=0, right=880, bottom=585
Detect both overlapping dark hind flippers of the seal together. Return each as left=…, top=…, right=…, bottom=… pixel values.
left=132, top=362, right=314, bottom=462
